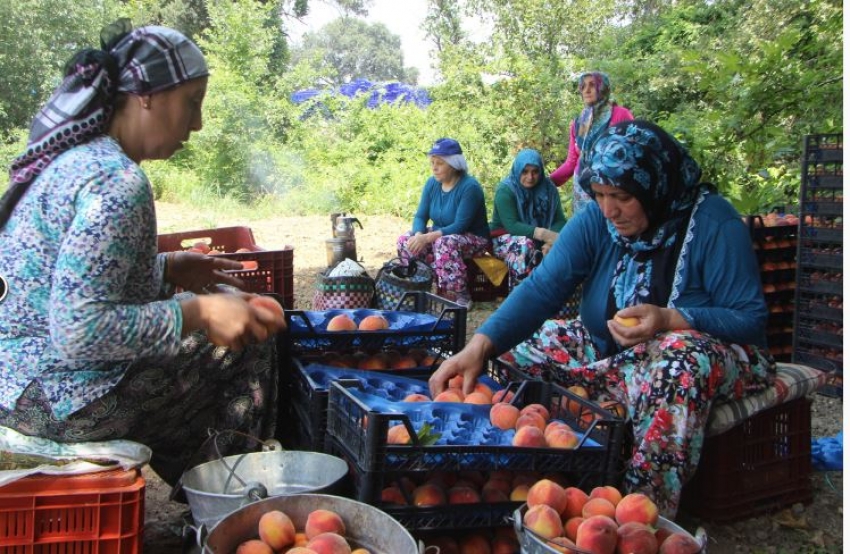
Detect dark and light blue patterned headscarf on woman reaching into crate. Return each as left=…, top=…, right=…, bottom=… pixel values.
left=579, top=120, right=713, bottom=320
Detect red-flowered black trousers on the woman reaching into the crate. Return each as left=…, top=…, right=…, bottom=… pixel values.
left=504, top=320, right=776, bottom=519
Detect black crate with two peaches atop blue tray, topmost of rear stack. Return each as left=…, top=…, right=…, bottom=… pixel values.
left=284, top=292, right=466, bottom=357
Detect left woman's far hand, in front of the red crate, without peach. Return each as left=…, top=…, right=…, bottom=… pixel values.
left=165, top=252, right=245, bottom=294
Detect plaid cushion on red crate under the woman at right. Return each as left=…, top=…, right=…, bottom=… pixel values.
left=706, top=363, right=827, bottom=437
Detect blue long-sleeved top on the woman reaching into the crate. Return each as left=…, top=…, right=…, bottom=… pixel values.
left=477, top=194, right=768, bottom=357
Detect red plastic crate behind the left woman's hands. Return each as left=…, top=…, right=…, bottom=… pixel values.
left=157, top=227, right=295, bottom=310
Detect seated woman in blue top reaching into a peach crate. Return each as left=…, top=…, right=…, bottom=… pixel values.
left=431, top=121, right=776, bottom=518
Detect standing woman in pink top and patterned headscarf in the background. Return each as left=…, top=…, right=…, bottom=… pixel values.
left=550, top=71, right=634, bottom=213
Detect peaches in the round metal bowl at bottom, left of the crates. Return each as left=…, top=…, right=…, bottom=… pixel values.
left=236, top=509, right=370, bottom=554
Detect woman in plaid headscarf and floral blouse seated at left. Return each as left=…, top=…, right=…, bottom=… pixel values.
left=0, top=20, right=284, bottom=483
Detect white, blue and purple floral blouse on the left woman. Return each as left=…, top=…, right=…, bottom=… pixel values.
left=0, top=136, right=183, bottom=419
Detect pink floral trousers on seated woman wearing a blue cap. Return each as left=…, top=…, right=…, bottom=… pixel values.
left=396, top=231, right=490, bottom=295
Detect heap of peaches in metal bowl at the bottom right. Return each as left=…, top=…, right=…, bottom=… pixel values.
left=522, top=479, right=702, bottom=554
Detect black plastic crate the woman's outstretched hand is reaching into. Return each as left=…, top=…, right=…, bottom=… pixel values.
left=328, top=381, right=625, bottom=478
